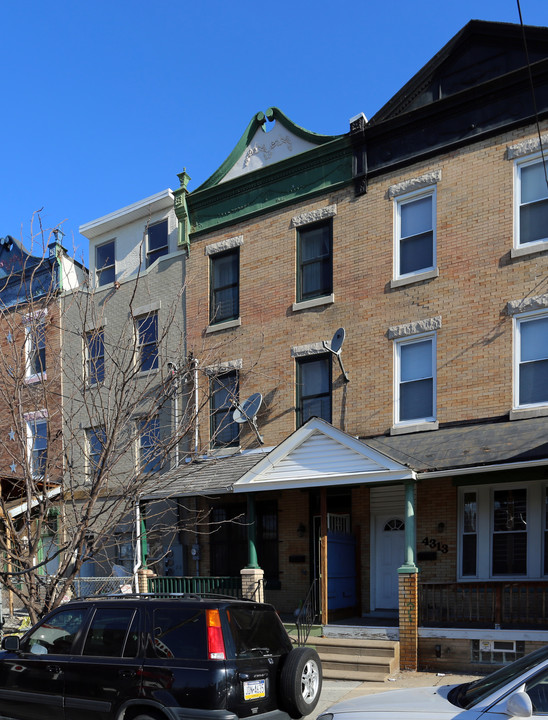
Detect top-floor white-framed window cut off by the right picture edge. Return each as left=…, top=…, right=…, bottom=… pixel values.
left=515, top=157, right=548, bottom=247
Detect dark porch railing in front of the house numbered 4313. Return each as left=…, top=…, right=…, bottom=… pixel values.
left=419, top=582, right=548, bottom=628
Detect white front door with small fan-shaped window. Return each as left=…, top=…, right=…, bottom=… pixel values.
left=375, top=515, right=405, bottom=610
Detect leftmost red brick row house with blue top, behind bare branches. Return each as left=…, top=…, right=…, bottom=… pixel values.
left=0, top=232, right=85, bottom=613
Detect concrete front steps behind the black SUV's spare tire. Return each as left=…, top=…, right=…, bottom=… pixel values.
left=307, top=637, right=400, bottom=682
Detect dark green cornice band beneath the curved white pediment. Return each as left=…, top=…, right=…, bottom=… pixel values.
left=175, top=137, right=352, bottom=241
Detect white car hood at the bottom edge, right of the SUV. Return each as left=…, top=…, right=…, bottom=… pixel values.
left=326, top=685, right=463, bottom=720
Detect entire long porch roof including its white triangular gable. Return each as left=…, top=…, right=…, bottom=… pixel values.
left=142, top=417, right=548, bottom=500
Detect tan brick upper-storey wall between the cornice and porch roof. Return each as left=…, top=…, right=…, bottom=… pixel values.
left=188, top=128, right=548, bottom=447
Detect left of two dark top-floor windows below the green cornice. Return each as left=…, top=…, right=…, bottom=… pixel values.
left=209, top=247, right=240, bottom=324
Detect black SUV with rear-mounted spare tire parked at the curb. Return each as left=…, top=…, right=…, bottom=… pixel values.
left=0, top=595, right=322, bottom=720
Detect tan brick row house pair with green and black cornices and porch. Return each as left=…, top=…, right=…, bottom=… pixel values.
left=134, top=21, right=548, bottom=669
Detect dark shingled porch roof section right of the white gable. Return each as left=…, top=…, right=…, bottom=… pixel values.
left=362, top=417, right=548, bottom=475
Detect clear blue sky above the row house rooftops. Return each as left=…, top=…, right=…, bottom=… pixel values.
left=0, top=0, right=548, bottom=259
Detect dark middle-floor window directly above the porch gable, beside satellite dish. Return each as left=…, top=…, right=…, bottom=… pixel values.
left=296, top=355, right=332, bottom=427
